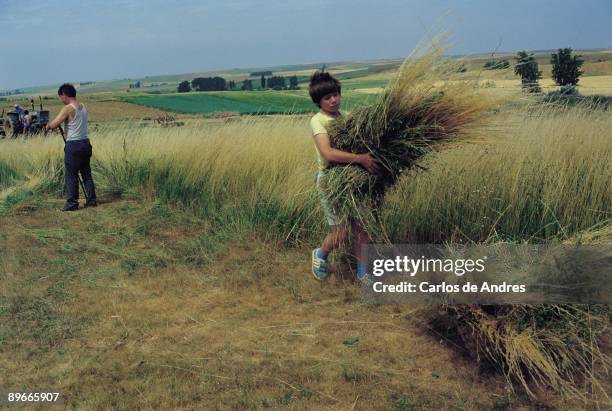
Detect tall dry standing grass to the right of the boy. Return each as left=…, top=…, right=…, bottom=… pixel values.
left=384, top=104, right=612, bottom=243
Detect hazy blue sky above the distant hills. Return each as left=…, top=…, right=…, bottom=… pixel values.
left=0, top=0, right=612, bottom=89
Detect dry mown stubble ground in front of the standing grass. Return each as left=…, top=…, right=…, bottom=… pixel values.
left=0, top=198, right=548, bottom=410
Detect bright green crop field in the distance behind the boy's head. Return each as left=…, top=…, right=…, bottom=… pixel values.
left=124, top=90, right=372, bottom=114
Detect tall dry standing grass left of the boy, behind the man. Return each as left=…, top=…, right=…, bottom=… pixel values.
left=0, top=117, right=324, bottom=240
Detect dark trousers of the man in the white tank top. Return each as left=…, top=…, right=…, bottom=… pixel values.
left=64, top=139, right=96, bottom=207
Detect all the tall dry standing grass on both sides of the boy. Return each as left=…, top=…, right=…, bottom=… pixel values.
left=0, top=101, right=612, bottom=243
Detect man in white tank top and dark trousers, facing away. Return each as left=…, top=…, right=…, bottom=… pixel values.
left=47, top=83, right=97, bottom=211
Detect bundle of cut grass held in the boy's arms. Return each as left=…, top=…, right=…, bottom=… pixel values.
left=322, top=43, right=495, bottom=233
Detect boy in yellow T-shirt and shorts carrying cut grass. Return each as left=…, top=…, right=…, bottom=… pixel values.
left=309, top=71, right=378, bottom=280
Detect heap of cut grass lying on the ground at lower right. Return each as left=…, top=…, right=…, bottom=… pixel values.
left=423, top=225, right=612, bottom=402
